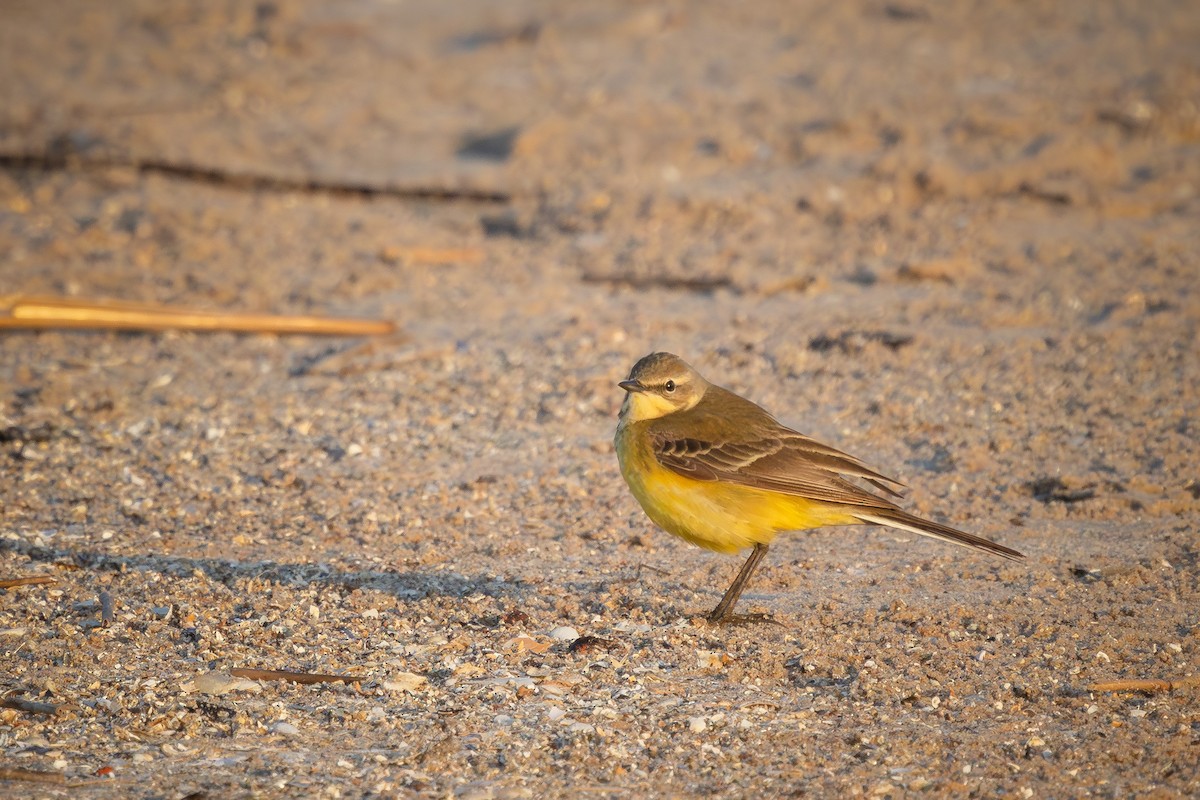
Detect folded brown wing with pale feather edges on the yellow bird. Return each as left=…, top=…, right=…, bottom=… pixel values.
left=653, top=427, right=902, bottom=509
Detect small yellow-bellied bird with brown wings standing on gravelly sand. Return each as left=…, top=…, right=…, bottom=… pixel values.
left=614, top=353, right=1025, bottom=624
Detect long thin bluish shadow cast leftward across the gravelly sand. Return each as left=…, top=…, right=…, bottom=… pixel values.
left=0, top=540, right=529, bottom=600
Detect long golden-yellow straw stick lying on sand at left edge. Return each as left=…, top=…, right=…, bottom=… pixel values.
left=0, top=295, right=396, bottom=336
